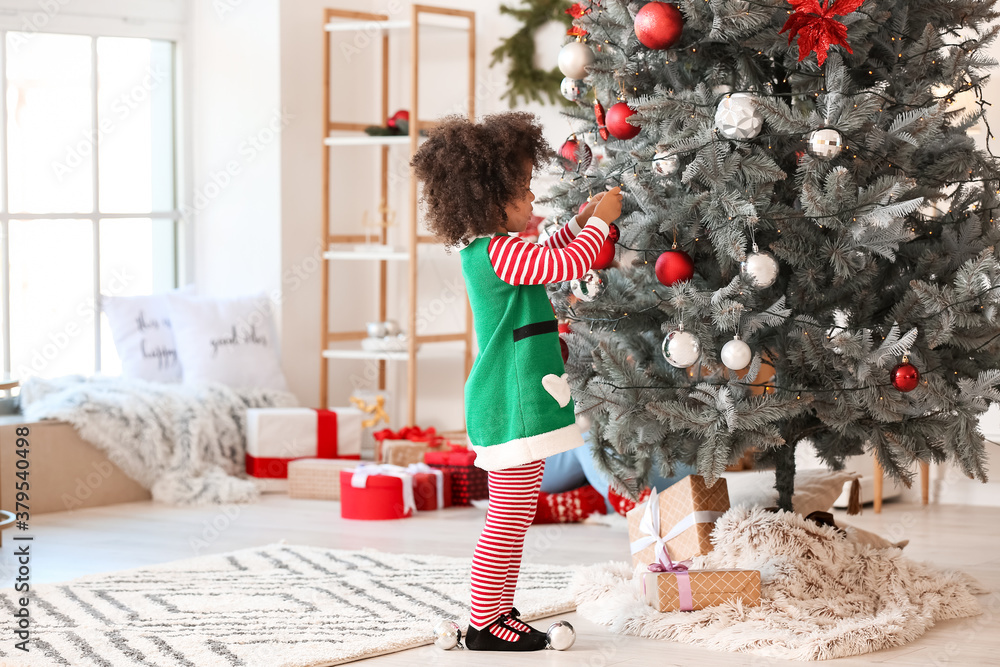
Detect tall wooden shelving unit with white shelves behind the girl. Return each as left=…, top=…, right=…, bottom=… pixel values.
left=320, top=3, right=476, bottom=424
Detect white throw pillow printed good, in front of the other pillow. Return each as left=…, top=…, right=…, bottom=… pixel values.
left=169, top=292, right=288, bottom=391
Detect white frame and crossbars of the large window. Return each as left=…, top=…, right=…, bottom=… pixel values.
left=0, top=5, right=192, bottom=377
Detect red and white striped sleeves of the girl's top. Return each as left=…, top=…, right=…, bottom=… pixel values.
left=488, top=215, right=608, bottom=285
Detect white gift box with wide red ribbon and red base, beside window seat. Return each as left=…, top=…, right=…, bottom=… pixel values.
left=246, top=408, right=363, bottom=491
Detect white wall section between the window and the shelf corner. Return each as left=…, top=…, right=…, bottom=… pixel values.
left=188, top=0, right=287, bottom=299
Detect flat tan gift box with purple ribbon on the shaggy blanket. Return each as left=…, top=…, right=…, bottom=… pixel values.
left=642, top=569, right=760, bottom=611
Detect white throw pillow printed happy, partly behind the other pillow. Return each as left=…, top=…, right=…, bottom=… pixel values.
left=101, top=285, right=194, bottom=382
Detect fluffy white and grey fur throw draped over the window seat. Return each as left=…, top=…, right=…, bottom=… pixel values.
left=20, top=375, right=298, bottom=505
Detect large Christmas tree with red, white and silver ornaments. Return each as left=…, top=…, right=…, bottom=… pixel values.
left=543, top=0, right=1000, bottom=509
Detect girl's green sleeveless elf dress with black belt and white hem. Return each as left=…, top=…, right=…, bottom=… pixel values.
left=460, top=227, right=583, bottom=470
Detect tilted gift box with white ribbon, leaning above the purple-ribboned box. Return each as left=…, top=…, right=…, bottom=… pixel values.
left=625, top=475, right=729, bottom=567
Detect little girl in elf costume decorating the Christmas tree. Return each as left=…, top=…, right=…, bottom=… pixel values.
left=410, top=113, right=622, bottom=651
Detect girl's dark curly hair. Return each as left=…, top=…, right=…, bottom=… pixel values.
left=410, top=111, right=553, bottom=247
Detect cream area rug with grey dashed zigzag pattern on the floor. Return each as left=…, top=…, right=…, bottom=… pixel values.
left=0, top=543, right=575, bottom=667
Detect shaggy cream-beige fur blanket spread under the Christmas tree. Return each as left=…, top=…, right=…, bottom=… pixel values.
left=574, top=506, right=986, bottom=660
